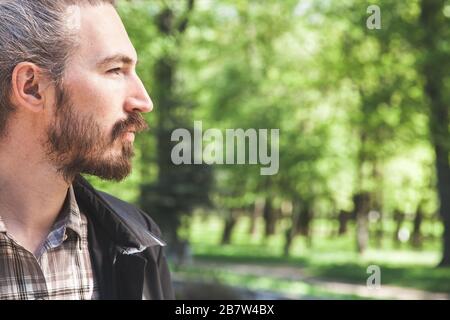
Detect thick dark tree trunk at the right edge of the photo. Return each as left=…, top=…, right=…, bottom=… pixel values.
left=420, top=0, right=450, bottom=266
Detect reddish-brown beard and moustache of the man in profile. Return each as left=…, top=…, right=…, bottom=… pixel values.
left=46, top=88, right=148, bottom=181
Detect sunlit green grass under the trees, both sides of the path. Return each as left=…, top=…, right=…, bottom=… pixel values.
left=174, top=216, right=450, bottom=298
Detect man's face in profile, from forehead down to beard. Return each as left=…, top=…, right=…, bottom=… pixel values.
left=47, top=5, right=153, bottom=180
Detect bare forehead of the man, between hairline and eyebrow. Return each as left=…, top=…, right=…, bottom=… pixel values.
left=66, top=4, right=137, bottom=65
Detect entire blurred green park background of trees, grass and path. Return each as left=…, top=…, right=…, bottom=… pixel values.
left=89, top=0, right=450, bottom=299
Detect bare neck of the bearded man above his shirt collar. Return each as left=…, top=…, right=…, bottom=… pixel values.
left=0, top=131, right=70, bottom=252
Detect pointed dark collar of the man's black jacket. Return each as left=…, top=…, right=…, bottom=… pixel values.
left=73, top=175, right=166, bottom=254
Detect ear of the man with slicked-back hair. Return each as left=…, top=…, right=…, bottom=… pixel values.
left=11, top=62, right=49, bottom=112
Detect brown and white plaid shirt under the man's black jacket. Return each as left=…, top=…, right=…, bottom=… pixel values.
left=0, top=186, right=99, bottom=300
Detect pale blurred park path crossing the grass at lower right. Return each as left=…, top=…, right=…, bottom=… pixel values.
left=194, top=261, right=450, bottom=300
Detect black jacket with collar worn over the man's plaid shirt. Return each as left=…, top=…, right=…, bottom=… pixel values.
left=73, top=176, right=174, bottom=300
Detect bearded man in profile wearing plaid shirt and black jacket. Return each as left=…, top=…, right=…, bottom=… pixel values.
left=0, top=0, right=173, bottom=299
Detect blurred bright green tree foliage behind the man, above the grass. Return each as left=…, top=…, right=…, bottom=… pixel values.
left=86, top=0, right=450, bottom=268
